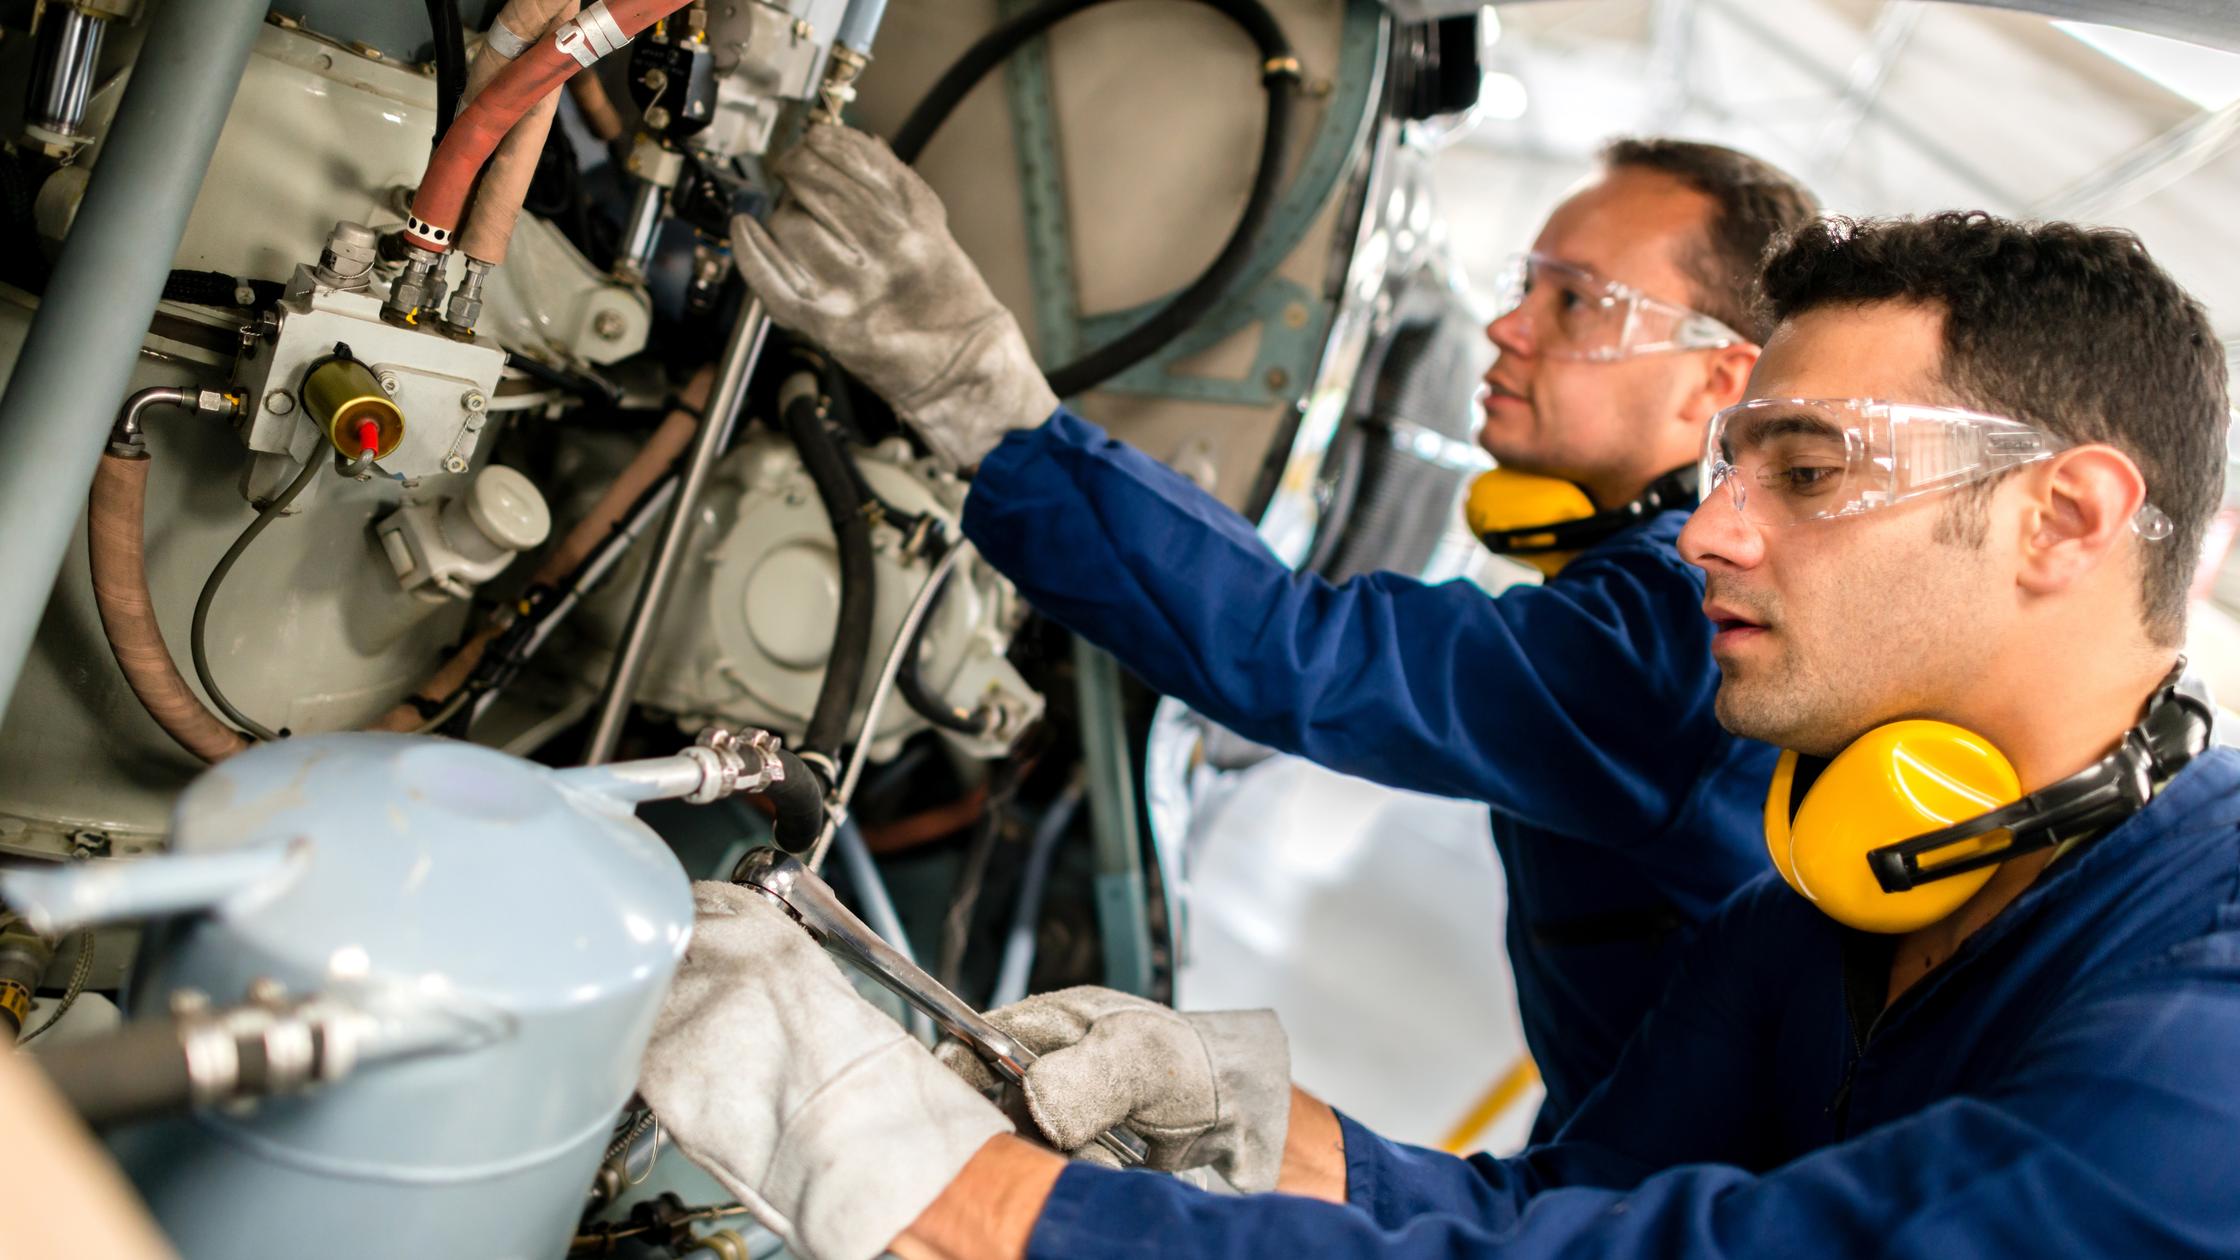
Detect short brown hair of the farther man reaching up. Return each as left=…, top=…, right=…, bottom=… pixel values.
left=1602, top=137, right=1819, bottom=345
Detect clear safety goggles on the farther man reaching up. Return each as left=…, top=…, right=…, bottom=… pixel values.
left=1494, top=253, right=1749, bottom=363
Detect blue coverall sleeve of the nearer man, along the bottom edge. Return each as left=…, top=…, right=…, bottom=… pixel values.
left=1030, top=973, right=2240, bottom=1260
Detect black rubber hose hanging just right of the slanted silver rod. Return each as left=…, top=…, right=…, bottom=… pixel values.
left=780, top=370, right=878, bottom=758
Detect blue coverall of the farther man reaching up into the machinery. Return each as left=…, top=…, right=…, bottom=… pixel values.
left=963, top=408, right=1774, bottom=1137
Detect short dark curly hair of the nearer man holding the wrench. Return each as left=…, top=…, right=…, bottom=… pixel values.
left=1763, top=211, right=2231, bottom=646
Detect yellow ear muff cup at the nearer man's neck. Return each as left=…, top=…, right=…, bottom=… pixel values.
left=1765, top=720, right=2023, bottom=933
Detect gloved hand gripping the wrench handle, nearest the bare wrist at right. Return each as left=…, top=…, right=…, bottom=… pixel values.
left=934, top=984, right=1290, bottom=1193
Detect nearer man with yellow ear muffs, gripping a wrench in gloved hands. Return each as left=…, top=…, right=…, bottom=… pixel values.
left=641, top=213, right=2240, bottom=1260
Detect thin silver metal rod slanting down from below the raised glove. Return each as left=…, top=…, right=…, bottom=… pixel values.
left=582, top=298, right=771, bottom=765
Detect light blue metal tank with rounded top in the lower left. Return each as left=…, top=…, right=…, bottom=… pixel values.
left=112, top=733, right=692, bottom=1260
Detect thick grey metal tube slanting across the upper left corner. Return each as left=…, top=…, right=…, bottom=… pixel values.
left=0, top=0, right=269, bottom=708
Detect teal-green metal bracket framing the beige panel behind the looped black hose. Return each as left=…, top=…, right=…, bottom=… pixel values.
left=999, top=0, right=1389, bottom=406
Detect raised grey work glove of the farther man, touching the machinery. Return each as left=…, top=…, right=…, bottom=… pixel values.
left=730, top=123, right=1057, bottom=469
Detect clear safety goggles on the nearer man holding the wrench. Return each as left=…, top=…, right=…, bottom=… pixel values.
left=1698, top=399, right=2171, bottom=540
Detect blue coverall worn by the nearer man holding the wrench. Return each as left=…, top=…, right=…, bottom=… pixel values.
left=1028, top=749, right=2240, bottom=1260
